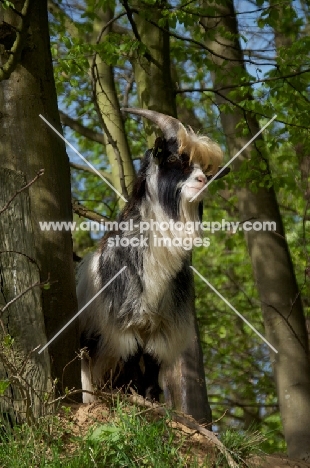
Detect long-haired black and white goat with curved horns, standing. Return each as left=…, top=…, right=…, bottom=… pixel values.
left=78, top=108, right=222, bottom=402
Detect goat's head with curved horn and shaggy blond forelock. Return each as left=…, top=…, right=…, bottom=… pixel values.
left=122, top=108, right=224, bottom=220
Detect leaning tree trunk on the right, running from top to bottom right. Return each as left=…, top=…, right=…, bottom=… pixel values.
left=201, top=1, right=310, bottom=459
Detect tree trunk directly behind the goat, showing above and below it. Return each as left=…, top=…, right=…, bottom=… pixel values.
left=134, top=5, right=212, bottom=423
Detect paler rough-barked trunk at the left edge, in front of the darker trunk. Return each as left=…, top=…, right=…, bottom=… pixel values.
left=0, top=168, right=52, bottom=422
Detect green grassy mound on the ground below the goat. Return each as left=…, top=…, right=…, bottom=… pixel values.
left=0, top=403, right=266, bottom=468
